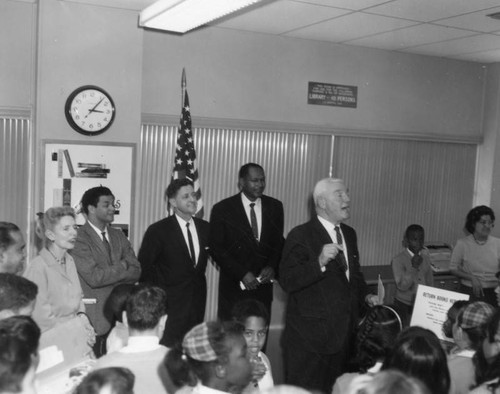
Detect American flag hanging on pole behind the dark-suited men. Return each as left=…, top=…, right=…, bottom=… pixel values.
left=169, top=90, right=203, bottom=218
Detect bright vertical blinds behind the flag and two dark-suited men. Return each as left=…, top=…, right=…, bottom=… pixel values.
left=135, top=124, right=333, bottom=318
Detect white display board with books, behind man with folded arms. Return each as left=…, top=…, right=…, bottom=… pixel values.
left=42, top=140, right=135, bottom=237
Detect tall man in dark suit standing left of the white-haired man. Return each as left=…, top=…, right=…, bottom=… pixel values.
left=210, top=163, right=283, bottom=319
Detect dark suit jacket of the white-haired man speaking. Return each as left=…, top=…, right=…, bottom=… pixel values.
left=280, top=216, right=368, bottom=354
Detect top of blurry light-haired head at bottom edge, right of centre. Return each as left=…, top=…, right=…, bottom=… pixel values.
left=343, top=369, right=430, bottom=394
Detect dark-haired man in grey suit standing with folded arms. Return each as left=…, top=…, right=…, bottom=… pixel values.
left=71, top=186, right=141, bottom=357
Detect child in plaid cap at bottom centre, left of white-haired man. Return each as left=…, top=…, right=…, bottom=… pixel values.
left=164, top=322, right=252, bottom=394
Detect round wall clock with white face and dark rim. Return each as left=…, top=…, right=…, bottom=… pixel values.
left=64, top=85, right=115, bottom=135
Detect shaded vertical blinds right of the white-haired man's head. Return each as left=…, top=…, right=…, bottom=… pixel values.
left=333, top=137, right=477, bottom=265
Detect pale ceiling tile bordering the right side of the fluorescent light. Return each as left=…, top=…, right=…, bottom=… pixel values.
left=214, top=0, right=351, bottom=34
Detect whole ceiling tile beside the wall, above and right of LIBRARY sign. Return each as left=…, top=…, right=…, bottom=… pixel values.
left=345, top=23, right=475, bottom=50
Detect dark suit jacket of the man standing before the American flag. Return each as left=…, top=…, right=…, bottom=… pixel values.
left=139, top=216, right=209, bottom=347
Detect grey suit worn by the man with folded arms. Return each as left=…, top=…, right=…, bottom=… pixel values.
left=71, top=222, right=141, bottom=335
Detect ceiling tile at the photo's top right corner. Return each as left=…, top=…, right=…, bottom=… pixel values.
left=369, top=0, right=498, bottom=22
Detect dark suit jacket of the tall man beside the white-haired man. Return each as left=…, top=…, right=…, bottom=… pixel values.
left=210, top=194, right=284, bottom=315
